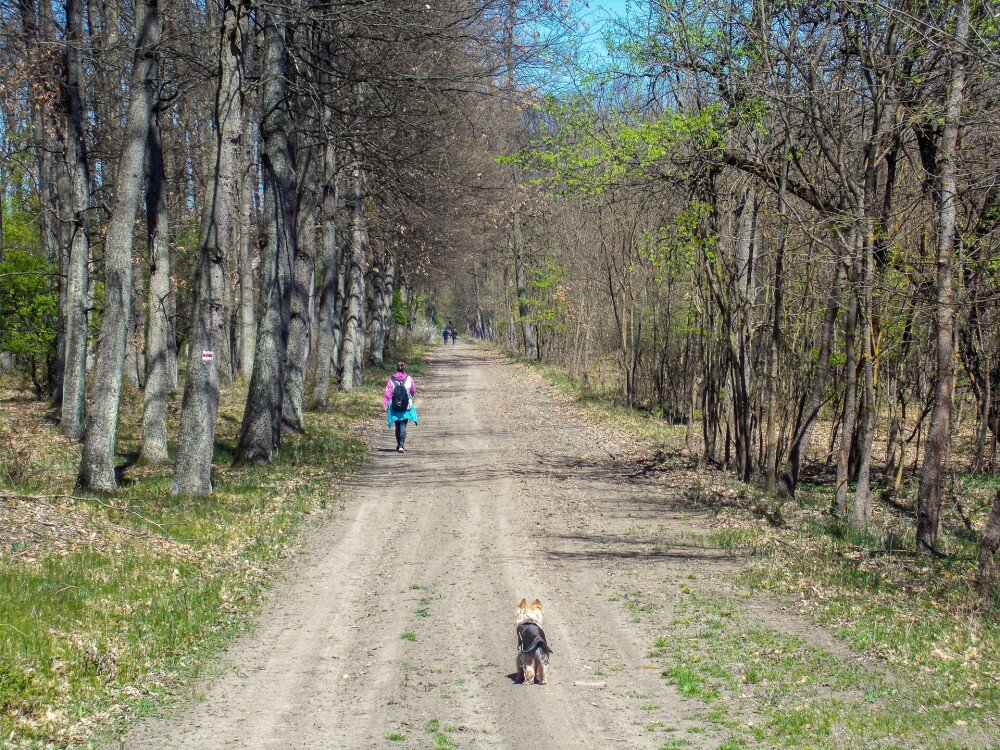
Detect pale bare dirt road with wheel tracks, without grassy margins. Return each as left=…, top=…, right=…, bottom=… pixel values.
left=123, top=344, right=731, bottom=750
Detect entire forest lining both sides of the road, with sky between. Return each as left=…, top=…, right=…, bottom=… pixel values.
left=0, top=0, right=1000, bottom=741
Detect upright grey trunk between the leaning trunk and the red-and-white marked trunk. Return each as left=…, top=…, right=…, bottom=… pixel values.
left=141, top=114, right=171, bottom=464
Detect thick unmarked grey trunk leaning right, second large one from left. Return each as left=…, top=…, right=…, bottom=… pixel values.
left=79, top=0, right=160, bottom=491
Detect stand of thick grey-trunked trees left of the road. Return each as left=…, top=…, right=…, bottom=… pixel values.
left=0, top=2, right=530, bottom=484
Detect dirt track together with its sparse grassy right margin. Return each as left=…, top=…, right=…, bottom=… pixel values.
left=105, top=343, right=1000, bottom=750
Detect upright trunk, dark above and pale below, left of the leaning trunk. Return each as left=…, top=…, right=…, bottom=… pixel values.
left=60, top=0, right=90, bottom=440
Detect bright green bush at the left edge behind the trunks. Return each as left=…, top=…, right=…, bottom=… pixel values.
left=0, top=248, right=59, bottom=363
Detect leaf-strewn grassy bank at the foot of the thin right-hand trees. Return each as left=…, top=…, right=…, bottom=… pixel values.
left=692, top=480, right=1000, bottom=747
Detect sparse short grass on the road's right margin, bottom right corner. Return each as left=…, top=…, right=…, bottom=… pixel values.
left=651, top=592, right=1000, bottom=750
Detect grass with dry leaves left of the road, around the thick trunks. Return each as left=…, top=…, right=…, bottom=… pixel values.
left=0, top=344, right=426, bottom=748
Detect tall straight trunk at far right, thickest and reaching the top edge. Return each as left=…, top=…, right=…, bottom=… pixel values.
left=917, top=0, right=970, bottom=552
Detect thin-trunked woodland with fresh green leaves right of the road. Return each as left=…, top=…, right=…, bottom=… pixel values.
left=455, top=2, right=1000, bottom=597
